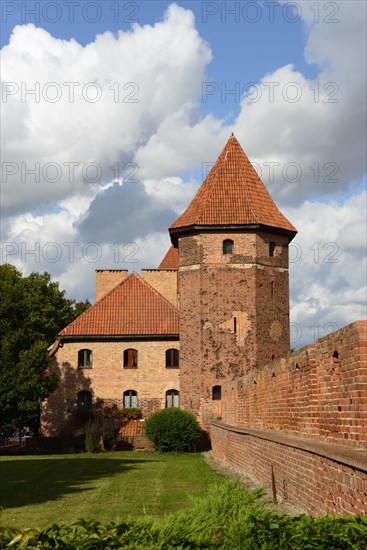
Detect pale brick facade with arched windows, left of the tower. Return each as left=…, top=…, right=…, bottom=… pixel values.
left=41, top=340, right=180, bottom=436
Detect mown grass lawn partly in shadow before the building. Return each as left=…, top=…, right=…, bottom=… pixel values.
left=0, top=451, right=223, bottom=529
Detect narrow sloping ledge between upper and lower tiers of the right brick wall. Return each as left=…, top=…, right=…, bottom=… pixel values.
left=211, top=420, right=367, bottom=473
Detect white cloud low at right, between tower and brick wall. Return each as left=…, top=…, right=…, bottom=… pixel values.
left=284, top=192, right=367, bottom=347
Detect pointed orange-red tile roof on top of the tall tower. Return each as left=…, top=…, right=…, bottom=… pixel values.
left=170, top=134, right=297, bottom=236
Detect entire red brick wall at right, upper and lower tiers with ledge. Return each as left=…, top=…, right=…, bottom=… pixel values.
left=211, top=321, right=367, bottom=514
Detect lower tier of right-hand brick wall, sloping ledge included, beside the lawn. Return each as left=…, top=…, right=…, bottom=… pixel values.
left=211, top=422, right=367, bottom=515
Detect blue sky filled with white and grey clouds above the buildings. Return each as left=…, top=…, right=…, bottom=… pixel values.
left=1, top=0, right=367, bottom=348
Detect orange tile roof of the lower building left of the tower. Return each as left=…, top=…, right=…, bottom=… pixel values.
left=59, top=273, right=179, bottom=337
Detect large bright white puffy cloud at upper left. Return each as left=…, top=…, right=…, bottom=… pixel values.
left=2, top=4, right=211, bottom=215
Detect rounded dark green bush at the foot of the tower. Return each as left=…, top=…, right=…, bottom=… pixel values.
left=145, top=408, right=201, bottom=453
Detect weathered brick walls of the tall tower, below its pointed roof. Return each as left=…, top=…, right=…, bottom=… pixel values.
left=179, top=233, right=289, bottom=427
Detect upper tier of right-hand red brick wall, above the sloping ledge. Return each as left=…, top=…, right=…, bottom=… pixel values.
left=221, top=321, right=367, bottom=446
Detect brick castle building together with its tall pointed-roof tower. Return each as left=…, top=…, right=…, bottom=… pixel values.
left=42, top=135, right=296, bottom=435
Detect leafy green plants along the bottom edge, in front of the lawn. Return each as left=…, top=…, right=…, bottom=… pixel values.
left=0, top=481, right=367, bottom=550
